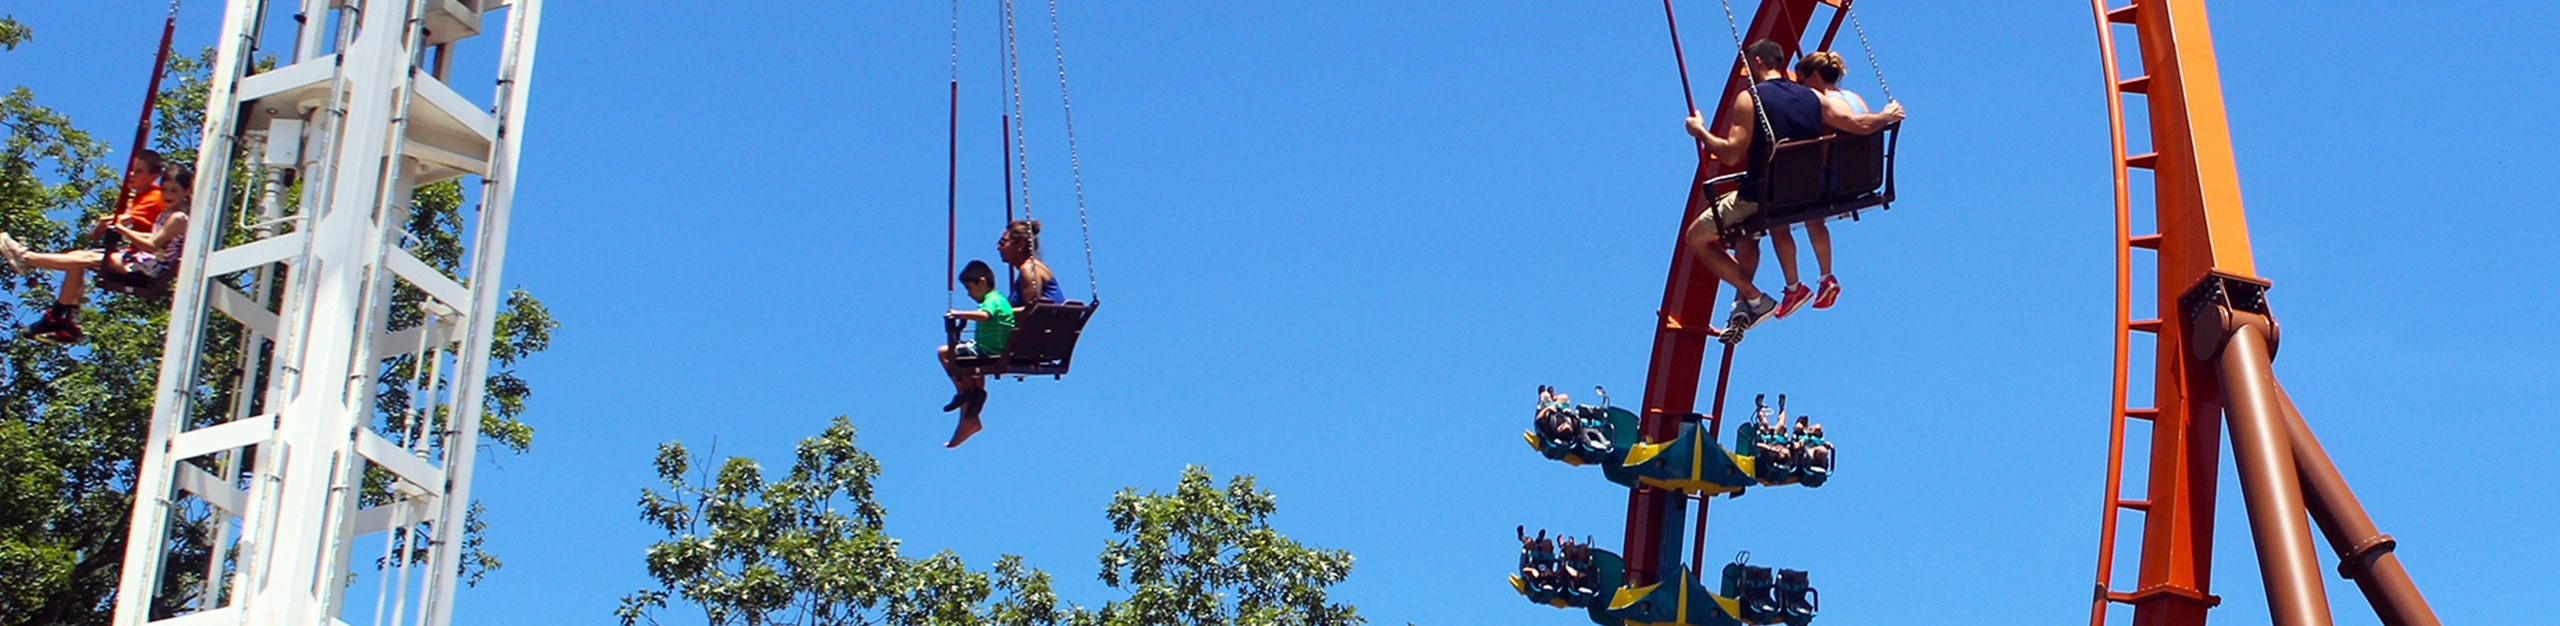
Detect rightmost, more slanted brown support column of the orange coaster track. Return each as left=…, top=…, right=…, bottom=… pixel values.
left=2273, top=383, right=2442, bottom=626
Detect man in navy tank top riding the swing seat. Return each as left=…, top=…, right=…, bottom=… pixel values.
left=1682, top=38, right=1823, bottom=330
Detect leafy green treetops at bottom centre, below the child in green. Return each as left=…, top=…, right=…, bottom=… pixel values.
left=614, top=416, right=1362, bottom=626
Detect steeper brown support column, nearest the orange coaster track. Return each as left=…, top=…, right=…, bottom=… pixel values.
left=2199, top=325, right=2330, bottom=626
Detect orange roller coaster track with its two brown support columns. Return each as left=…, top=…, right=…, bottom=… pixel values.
left=2089, top=0, right=2437, bottom=626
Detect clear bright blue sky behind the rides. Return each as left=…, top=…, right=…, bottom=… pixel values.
left=0, top=0, right=2560, bottom=623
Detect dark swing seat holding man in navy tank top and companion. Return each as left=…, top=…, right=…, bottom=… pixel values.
left=1705, top=123, right=1902, bottom=233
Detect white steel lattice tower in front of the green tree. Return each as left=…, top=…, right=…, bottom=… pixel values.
left=115, top=0, right=543, bottom=626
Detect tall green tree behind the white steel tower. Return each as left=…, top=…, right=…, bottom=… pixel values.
left=0, top=30, right=558, bottom=626
